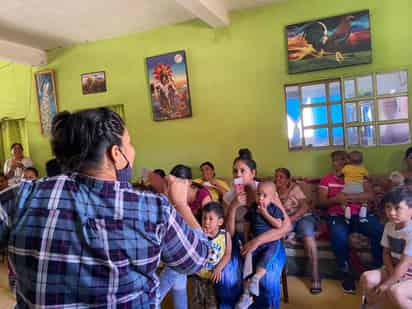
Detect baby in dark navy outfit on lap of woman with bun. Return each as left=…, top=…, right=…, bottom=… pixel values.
left=236, top=181, right=285, bottom=309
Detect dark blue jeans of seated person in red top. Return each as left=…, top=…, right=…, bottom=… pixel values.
left=328, top=214, right=384, bottom=271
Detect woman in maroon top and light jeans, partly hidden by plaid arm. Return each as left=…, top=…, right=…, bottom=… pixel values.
left=159, top=164, right=212, bottom=309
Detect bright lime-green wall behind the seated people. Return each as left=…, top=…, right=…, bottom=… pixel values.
left=0, top=0, right=412, bottom=176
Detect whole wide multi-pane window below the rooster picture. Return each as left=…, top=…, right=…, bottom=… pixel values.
left=285, top=71, right=410, bottom=150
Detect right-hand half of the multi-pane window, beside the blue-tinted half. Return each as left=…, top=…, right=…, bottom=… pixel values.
left=343, top=71, right=410, bottom=146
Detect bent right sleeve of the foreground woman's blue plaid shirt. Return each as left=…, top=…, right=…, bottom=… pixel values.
left=162, top=207, right=209, bottom=274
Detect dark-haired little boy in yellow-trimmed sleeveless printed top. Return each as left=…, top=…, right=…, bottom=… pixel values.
left=191, top=202, right=232, bottom=309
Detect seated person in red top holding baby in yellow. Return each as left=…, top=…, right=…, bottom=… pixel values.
left=319, top=151, right=383, bottom=294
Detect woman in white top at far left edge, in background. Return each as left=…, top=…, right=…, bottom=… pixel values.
left=4, top=143, right=33, bottom=185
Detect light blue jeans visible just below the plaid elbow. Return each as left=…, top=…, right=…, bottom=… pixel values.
left=159, top=267, right=187, bottom=309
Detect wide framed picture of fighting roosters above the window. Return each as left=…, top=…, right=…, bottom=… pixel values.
left=286, top=10, right=372, bottom=74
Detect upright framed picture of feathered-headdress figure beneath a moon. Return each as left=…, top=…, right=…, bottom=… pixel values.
left=146, top=50, right=192, bottom=121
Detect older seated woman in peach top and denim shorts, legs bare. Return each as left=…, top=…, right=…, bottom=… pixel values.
left=275, top=168, right=322, bottom=294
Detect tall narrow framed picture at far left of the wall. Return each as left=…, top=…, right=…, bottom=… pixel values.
left=34, top=70, right=57, bottom=136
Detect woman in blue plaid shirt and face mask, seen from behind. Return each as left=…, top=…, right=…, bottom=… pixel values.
left=0, top=108, right=209, bottom=308
